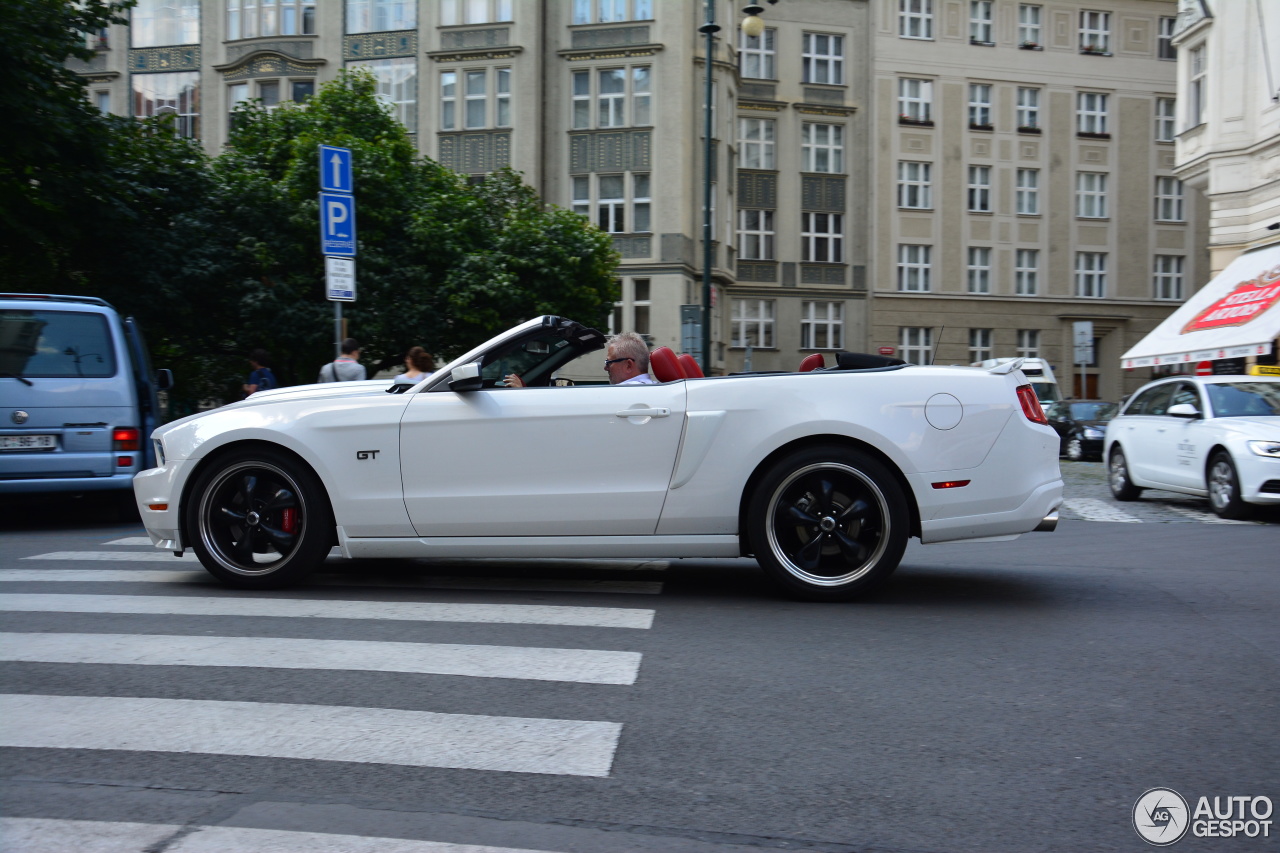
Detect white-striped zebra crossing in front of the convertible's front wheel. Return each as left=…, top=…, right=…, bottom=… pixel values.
left=0, top=537, right=667, bottom=853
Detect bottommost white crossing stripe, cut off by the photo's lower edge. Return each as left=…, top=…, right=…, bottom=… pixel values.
left=0, top=817, right=560, bottom=853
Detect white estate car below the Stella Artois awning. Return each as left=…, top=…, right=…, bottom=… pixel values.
left=1102, top=375, right=1280, bottom=519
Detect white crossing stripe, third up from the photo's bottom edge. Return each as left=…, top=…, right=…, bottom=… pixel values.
left=0, top=633, right=640, bottom=684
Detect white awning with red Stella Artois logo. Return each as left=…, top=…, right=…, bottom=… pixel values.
left=1120, top=243, right=1280, bottom=368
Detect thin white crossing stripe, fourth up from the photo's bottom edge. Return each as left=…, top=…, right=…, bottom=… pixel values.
left=0, top=593, right=654, bottom=629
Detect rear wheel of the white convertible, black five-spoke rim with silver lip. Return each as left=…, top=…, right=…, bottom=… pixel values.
left=748, top=446, right=909, bottom=601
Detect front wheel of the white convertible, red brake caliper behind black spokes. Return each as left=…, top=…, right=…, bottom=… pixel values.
left=186, top=448, right=333, bottom=589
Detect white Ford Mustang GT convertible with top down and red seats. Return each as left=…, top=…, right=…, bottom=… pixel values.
left=134, top=316, right=1062, bottom=599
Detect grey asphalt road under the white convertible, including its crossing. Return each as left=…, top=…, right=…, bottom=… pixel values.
left=0, top=481, right=1280, bottom=853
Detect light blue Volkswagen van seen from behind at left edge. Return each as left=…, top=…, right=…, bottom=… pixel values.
left=0, top=293, right=173, bottom=494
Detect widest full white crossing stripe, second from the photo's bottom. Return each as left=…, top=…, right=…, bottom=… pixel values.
left=0, top=694, right=622, bottom=776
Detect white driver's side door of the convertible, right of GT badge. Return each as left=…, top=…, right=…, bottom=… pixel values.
left=401, top=382, right=685, bottom=537
